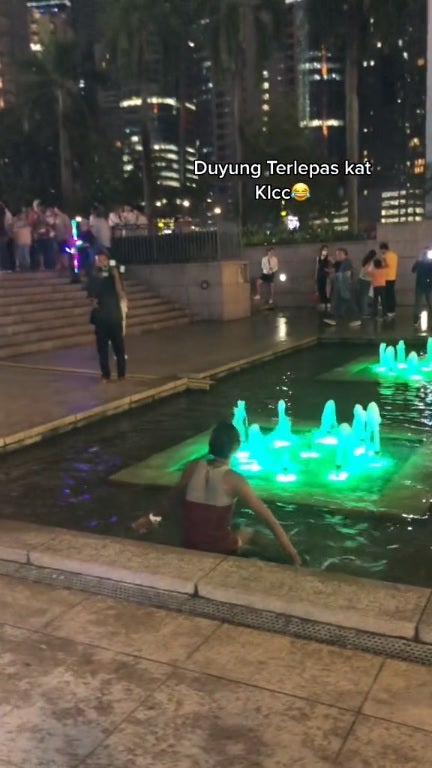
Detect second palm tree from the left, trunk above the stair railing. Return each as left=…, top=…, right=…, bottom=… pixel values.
left=103, top=0, right=191, bottom=223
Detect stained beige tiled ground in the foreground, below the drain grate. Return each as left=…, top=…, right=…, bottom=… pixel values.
left=0, top=577, right=432, bottom=768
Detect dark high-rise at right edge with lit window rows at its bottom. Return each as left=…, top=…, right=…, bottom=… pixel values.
left=360, top=0, right=426, bottom=223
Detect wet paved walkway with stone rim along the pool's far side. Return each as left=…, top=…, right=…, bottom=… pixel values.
left=0, top=308, right=418, bottom=449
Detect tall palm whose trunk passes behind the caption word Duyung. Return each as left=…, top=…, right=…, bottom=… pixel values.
left=201, top=0, right=285, bottom=222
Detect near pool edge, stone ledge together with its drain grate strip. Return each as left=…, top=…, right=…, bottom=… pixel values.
left=0, top=520, right=432, bottom=665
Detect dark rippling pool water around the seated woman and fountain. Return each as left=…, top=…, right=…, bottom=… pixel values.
left=0, top=343, right=432, bottom=587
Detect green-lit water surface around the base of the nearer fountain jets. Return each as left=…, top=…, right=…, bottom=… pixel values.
left=111, top=422, right=432, bottom=517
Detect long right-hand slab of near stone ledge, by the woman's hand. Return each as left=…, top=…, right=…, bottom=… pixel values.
left=197, top=558, right=431, bottom=640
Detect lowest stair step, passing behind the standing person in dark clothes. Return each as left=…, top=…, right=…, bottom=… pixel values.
left=0, top=316, right=191, bottom=360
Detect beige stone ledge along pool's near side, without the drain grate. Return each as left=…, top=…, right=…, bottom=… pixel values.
left=0, top=520, right=432, bottom=645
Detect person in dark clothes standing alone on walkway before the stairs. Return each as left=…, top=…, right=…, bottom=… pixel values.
left=87, top=251, right=126, bottom=383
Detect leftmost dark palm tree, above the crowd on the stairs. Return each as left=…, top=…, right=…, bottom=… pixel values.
left=19, top=38, right=82, bottom=212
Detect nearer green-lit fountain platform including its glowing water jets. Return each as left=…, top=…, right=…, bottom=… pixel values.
left=111, top=400, right=432, bottom=517
